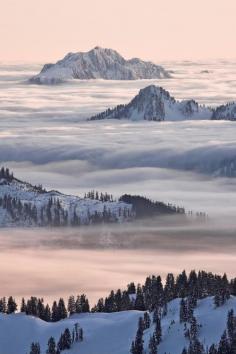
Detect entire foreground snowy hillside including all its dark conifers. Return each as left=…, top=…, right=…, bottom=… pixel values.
left=0, top=271, right=236, bottom=354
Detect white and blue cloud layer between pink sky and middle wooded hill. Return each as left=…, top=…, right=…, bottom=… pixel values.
left=0, top=61, right=236, bottom=214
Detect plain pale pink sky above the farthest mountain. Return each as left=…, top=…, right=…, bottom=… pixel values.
left=0, top=0, right=236, bottom=62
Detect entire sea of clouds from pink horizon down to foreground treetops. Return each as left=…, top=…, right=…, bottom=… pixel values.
left=0, top=61, right=236, bottom=301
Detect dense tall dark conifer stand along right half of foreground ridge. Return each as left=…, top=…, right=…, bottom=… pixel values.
left=92, top=270, right=236, bottom=314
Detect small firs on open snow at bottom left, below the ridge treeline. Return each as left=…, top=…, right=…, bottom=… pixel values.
left=29, top=323, right=84, bottom=354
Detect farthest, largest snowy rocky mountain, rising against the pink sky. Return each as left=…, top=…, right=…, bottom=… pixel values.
left=30, top=47, right=170, bottom=84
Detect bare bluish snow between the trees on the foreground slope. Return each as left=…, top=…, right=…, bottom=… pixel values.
left=0, top=297, right=236, bottom=354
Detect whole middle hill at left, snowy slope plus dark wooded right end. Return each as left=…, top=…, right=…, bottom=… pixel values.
left=0, top=167, right=185, bottom=227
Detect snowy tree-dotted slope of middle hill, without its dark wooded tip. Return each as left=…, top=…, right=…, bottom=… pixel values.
left=0, top=174, right=132, bottom=227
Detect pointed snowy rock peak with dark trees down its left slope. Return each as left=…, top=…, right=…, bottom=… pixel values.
left=90, top=85, right=212, bottom=121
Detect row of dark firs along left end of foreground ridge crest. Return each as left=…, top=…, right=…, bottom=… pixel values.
left=0, top=294, right=90, bottom=322
